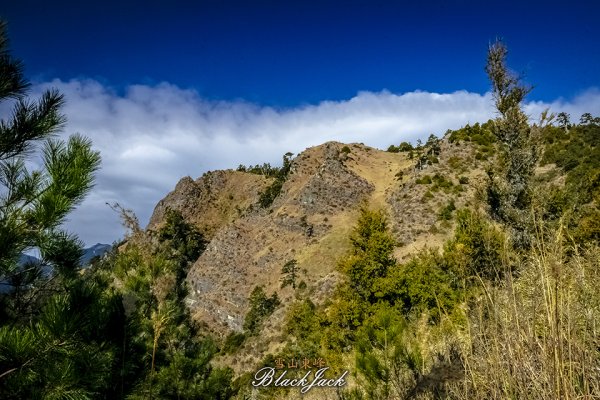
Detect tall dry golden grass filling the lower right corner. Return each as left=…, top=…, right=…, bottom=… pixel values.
left=450, top=227, right=600, bottom=399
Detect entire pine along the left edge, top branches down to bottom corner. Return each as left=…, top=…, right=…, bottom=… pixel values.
left=0, top=21, right=109, bottom=399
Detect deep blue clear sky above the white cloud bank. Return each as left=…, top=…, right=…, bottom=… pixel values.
left=0, top=0, right=600, bottom=107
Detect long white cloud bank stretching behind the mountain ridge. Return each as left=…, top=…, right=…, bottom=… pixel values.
left=22, top=80, right=600, bottom=245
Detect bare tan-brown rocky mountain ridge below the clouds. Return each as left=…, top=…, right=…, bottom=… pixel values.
left=148, top=137, right=486, bottom=371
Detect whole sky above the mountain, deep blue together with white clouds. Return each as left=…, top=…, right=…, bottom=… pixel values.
left=0, top=0, right=600, bottom=245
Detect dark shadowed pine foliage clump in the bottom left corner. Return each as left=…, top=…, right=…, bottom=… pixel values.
left=0, top=280, right=125, bottom=399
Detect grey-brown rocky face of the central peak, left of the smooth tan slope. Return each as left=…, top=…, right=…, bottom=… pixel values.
left=183, top=143, right=373, bottom=331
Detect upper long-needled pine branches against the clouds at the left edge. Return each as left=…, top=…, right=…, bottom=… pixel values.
left=0, top=22, right=100, bottom=319
